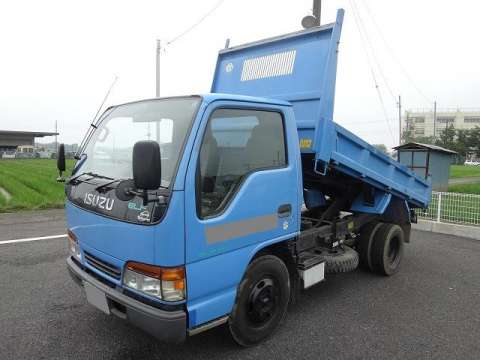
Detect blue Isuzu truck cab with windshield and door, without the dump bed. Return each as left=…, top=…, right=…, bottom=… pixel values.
left=66, top=94, right=302, bottom=338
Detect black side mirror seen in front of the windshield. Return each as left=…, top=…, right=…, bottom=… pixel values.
left=132, top=140, right=162, bottom=191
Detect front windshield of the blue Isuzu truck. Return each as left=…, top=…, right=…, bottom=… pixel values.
left=80, top=97, right=201, bottom=187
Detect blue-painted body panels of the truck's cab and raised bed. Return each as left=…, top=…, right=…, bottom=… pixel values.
left=66, top=10, right=431, bottom=327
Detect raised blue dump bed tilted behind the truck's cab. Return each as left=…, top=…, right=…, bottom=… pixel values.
left=212, top=10, right=431, bottom=208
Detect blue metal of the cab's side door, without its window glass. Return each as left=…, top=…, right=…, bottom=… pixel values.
left=185, top=100, right=303, bottom=327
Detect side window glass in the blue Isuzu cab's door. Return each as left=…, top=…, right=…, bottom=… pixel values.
left=197, top=109, right=287, bottom=218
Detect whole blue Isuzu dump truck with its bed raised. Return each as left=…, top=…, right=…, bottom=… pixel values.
left=58, top=10, right=431, bottom=346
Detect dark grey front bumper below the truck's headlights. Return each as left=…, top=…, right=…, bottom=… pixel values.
left=67, top=257, right=187, bottom=343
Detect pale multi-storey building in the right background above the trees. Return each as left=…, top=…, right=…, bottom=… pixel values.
left=402, top=109, right=480, bottom=138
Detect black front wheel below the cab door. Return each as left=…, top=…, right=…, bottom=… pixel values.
left=228, top=255, right=290, bottom=347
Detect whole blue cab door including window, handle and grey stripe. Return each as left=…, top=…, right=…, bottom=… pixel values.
left=185, top=102, right=299, bottom=326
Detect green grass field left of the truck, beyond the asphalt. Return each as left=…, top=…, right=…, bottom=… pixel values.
left=0, top=159, right=73, bottom=212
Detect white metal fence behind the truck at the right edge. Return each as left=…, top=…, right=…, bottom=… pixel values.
left=417, top=191, right=480, bottom=225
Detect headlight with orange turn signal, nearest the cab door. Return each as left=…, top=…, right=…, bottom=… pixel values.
left=123, top=261, right=185, bottom=301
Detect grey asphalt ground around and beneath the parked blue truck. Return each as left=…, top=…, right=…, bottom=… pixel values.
left=0, top=211, right=480, bottom=360
